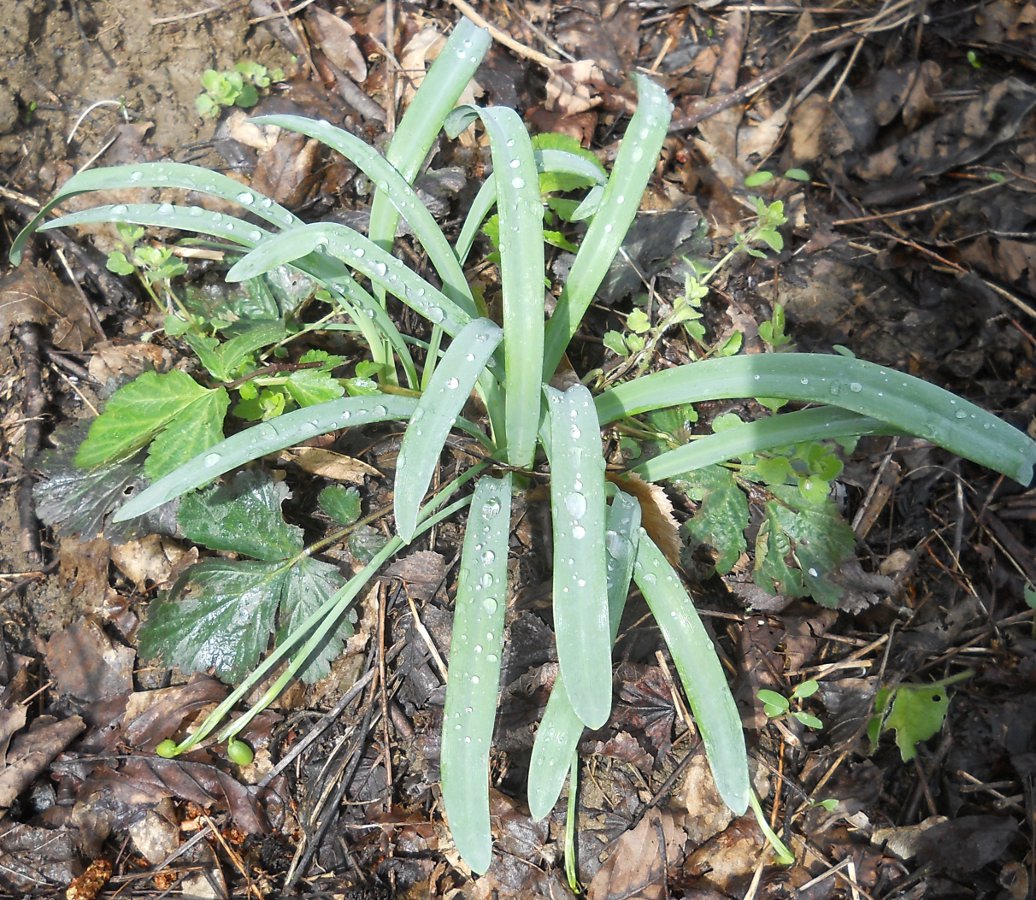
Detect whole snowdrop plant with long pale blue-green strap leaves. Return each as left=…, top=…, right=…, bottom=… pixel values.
left=12, top=22, right=1036, bottom=872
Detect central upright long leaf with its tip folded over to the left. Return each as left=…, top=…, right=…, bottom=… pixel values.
left=447, top=107, right=544, bottom=467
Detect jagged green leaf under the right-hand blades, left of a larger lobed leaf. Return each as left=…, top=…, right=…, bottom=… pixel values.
left=673, top=466, right=748, bottom=575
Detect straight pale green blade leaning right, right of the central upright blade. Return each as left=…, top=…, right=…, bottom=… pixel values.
left=543, top=76, right=672, bottom=381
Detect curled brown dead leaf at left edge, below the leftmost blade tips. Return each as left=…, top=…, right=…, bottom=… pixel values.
left=0, top=264, right=104, bottom=352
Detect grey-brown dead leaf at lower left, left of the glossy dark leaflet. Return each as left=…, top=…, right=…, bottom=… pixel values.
left=47, top=618, right=137, bottom=703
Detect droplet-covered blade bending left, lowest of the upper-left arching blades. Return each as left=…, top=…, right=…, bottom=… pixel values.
left=227, top=223, right=471, bottom=335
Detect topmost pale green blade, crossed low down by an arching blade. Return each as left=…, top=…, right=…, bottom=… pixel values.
left=368, top=19, right=492, bottom=256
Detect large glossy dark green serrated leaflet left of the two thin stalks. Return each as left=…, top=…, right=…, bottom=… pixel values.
left=139, top=559, right=288, bottom=684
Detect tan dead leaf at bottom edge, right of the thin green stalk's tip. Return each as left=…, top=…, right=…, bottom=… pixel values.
left=586, top=809, right=687, bottom=900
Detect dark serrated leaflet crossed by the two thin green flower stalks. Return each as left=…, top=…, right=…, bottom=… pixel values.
left=277, top=557, right=354, bottom=685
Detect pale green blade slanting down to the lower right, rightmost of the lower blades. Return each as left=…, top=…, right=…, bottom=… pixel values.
left=633, top=528, right=750, bottom=815
